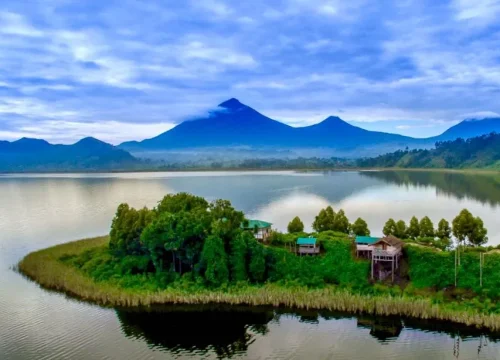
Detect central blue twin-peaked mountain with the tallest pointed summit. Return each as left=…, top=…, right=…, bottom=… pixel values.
left=119, top=99, right=419, bottom=155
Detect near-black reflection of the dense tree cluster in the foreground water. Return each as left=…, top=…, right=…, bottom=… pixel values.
left=116, top=306, right=275, bottom=358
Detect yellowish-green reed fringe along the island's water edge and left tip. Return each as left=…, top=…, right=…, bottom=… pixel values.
left=19, top=236, right=500, bottom=331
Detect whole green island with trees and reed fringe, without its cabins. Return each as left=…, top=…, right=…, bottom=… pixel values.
left=19, top=193, right=500, bottom=330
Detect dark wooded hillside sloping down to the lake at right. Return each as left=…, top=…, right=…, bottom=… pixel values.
left=357, top=133, right=500, bottom=169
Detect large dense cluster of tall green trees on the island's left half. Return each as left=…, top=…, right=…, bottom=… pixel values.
left=110, top=193, right=266, bottom=286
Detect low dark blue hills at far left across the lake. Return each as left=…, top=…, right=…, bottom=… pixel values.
left=0, top=137, right=140, bottom=172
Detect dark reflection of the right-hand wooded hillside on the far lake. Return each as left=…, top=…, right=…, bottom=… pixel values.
left=360, top=171, right=500, bottom=206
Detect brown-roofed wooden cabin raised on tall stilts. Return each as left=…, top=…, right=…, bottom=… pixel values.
left=371, top=235, right=404, bottom=281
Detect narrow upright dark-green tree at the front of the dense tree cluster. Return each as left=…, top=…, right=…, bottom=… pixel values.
left=201, top=235, right=229, bottom=286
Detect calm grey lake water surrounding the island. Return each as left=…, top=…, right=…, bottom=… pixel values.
left=0, top=172, right=500, bottom=360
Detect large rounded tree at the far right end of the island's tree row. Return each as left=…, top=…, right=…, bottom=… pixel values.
left=453, top=209, right=488, bottom=246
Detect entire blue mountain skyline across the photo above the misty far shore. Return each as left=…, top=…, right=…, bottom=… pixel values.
left=0, top=98, right=500, bottom=161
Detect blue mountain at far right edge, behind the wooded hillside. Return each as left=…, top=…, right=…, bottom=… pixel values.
left=435, top=118, right=500, bottom=141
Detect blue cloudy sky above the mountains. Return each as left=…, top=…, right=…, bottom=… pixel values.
left=0, top=0, right=500, bottom=144
